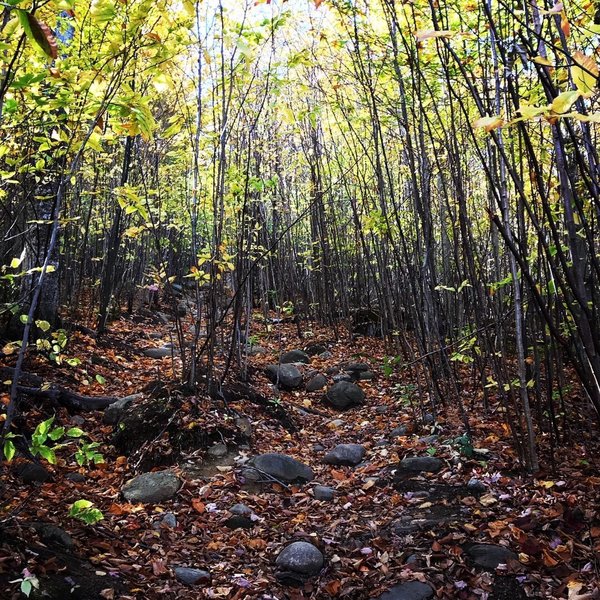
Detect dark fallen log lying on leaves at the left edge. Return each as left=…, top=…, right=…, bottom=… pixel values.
left=0, top=367, right=119, bottom=411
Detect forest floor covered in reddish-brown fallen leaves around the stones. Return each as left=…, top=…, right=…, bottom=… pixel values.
left=0, top=308, right=600, bottom=600
